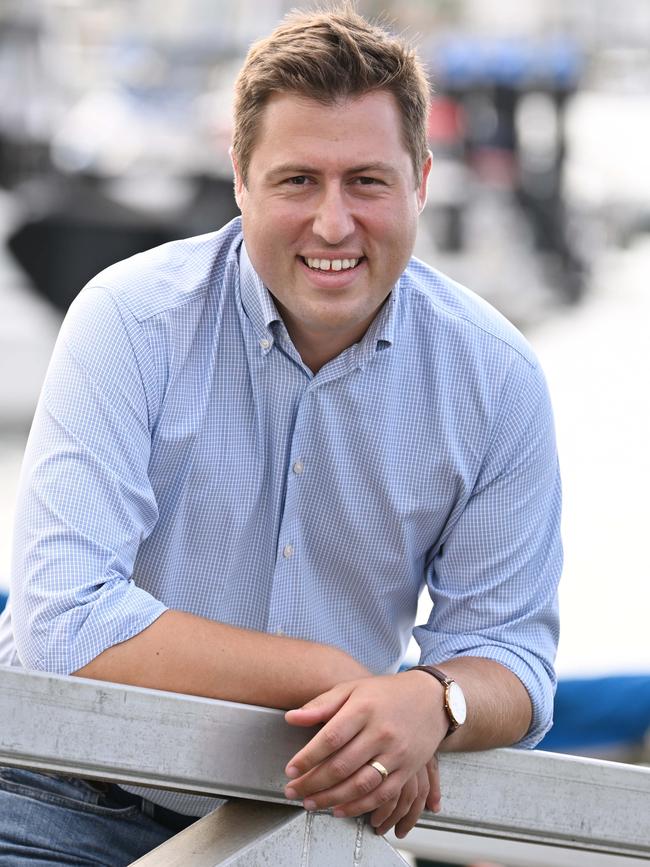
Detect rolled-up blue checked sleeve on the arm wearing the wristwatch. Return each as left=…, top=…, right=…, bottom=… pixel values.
left=414, top=363, right=562, bottom=747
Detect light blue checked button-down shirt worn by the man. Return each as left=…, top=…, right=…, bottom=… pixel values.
left=0, top=220, right=561, bottom=812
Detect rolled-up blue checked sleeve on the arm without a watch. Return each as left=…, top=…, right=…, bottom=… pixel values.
left=11, top=288, right=165, bottom=674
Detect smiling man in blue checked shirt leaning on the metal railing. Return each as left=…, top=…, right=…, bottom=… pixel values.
left=0, top=8, right=560, bottom=863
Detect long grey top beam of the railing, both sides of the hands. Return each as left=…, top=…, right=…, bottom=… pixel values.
left=0, top=667, right=650, bottom=861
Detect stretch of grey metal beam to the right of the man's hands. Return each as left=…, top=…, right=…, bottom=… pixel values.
left=410, top=749, right=650, bottom=860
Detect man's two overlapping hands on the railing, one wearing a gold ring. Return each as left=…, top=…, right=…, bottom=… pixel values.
left=285, top=672, right=448, bottom=836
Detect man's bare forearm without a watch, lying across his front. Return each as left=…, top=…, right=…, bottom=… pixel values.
left=75, top=611, right=368, bottom=708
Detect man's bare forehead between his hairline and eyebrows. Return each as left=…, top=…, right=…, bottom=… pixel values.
left=251, top=91, right=410, bottom=172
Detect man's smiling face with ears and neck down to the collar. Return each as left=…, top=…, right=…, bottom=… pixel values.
left=235, top=91, right=430, bottom=370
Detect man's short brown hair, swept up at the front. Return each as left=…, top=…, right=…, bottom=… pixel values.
left=232, top=3, right=429, bottom=183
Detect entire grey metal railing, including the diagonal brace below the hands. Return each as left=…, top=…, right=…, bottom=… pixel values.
left=0, top=667, right=650, bottom=867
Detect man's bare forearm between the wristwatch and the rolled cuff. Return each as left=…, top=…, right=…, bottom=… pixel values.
left=426, top=656, right=532, bottom=752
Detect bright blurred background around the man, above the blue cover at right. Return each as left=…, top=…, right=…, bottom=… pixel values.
left=0, top=0, right=650, bottom=692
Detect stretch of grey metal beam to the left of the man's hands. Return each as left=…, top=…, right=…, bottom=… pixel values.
left=0, top=666, right=315, bottom=803
